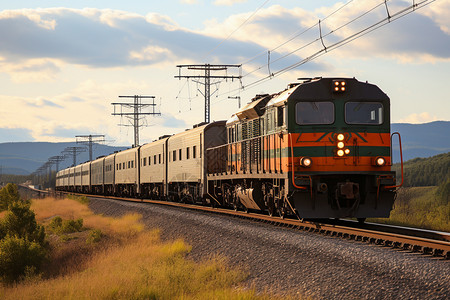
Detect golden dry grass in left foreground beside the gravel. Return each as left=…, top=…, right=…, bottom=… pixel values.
left=0, top=198, right=288, bottom=299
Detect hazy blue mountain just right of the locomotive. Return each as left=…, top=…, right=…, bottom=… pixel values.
left=391, top=121, right=450, bottom=162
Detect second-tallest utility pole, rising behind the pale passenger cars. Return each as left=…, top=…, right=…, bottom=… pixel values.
left=111, top=95, right=161, bottom=147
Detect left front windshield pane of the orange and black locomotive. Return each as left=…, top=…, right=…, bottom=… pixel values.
left=295, top=102, right=334, bottom=125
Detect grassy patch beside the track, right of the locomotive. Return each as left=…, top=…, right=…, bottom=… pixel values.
left=367, top=187, right=450, bottom=232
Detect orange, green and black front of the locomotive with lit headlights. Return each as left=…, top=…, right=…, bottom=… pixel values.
left=288, top=78, right=395, bottom=220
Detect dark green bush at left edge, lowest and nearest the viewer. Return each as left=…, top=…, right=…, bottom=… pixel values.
left=0, top=235, right=47, bottom=283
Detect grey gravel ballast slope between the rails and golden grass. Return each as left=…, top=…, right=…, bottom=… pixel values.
left=89, top=199, right=450, bottom=299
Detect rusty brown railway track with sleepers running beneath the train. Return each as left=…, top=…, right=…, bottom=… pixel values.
left=59, top=194, right=450, bottom=260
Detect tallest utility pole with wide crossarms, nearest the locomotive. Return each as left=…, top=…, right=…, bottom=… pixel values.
left=175, top=64, right=242, bottom=123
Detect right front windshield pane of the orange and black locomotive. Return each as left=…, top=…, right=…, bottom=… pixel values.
left=345, top=102, right=383, bottom=125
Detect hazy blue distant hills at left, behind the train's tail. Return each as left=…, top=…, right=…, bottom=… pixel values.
left=0, top=142, right=126, bottom=175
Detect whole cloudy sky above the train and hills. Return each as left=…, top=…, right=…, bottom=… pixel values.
left=0, top=0, right=450, bottom=146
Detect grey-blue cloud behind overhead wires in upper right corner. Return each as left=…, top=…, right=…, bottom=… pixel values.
left=317, top=1, right=450, bottom=63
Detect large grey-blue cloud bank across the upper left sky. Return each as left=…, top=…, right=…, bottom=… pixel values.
left=0, top=8, right=270, bottom=73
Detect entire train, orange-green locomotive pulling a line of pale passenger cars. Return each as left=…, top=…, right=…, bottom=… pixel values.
left=56, top=77, right=401, bottom=222
